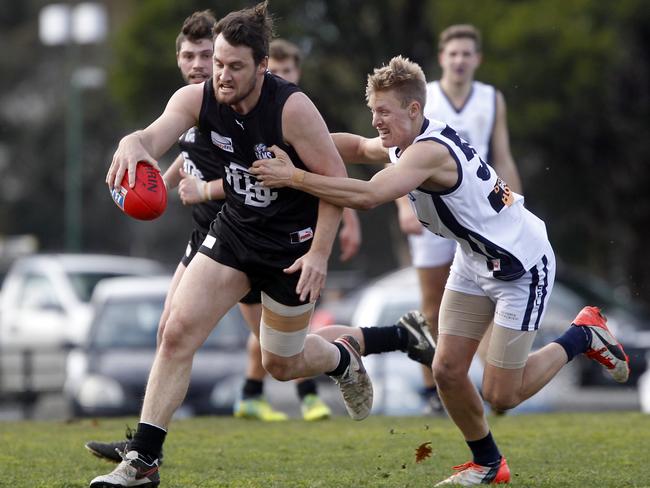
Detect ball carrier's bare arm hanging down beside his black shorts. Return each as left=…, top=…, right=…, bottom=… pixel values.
left=282, top=89, right=346, bottom=301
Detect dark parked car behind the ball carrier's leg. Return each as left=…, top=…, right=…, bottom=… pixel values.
left=64, top=277, right=248, bottom=416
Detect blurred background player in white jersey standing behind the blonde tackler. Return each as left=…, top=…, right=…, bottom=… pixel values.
left=397, top=24, right=522, bottom=411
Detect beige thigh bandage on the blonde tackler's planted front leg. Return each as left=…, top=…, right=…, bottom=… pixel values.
left=438, top=289, right=494, bottom=341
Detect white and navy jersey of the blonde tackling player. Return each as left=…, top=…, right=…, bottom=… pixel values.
left=390, top=119, right=549, bottom=281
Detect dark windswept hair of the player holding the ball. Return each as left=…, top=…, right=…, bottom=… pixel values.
left=212, top=1, right=273, bottom=64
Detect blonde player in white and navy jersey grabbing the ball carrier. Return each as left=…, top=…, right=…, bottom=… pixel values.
left=252, top=56, right=629, bottom=486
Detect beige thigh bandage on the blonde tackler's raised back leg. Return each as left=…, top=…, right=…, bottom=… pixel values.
left=486, top=324, right=537, bottom=369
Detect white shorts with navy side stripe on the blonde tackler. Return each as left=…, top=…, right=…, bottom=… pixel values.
left=445, top=246, right=555, bottom=330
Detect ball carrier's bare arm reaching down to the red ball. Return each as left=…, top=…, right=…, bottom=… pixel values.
left=106, top=84, right=203, bottom=187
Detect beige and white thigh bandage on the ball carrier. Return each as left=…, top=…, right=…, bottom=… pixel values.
left=260, top=293, right=314, bottom=357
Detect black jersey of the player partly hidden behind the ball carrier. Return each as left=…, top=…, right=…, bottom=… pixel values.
left=178, top=127, right=224, bottom=234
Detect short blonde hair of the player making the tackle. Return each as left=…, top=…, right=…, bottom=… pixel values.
left=366, top=56, right=427, bottom=110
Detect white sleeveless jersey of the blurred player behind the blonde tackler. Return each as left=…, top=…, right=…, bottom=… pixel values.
left=424, top=81, right=497, bottom=163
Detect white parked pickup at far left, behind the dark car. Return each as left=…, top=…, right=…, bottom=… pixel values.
left=0, top=254, right=166, bottom=348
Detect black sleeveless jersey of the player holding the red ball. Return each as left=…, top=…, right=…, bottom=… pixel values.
left=199, top=72, right=318, bottom=255
